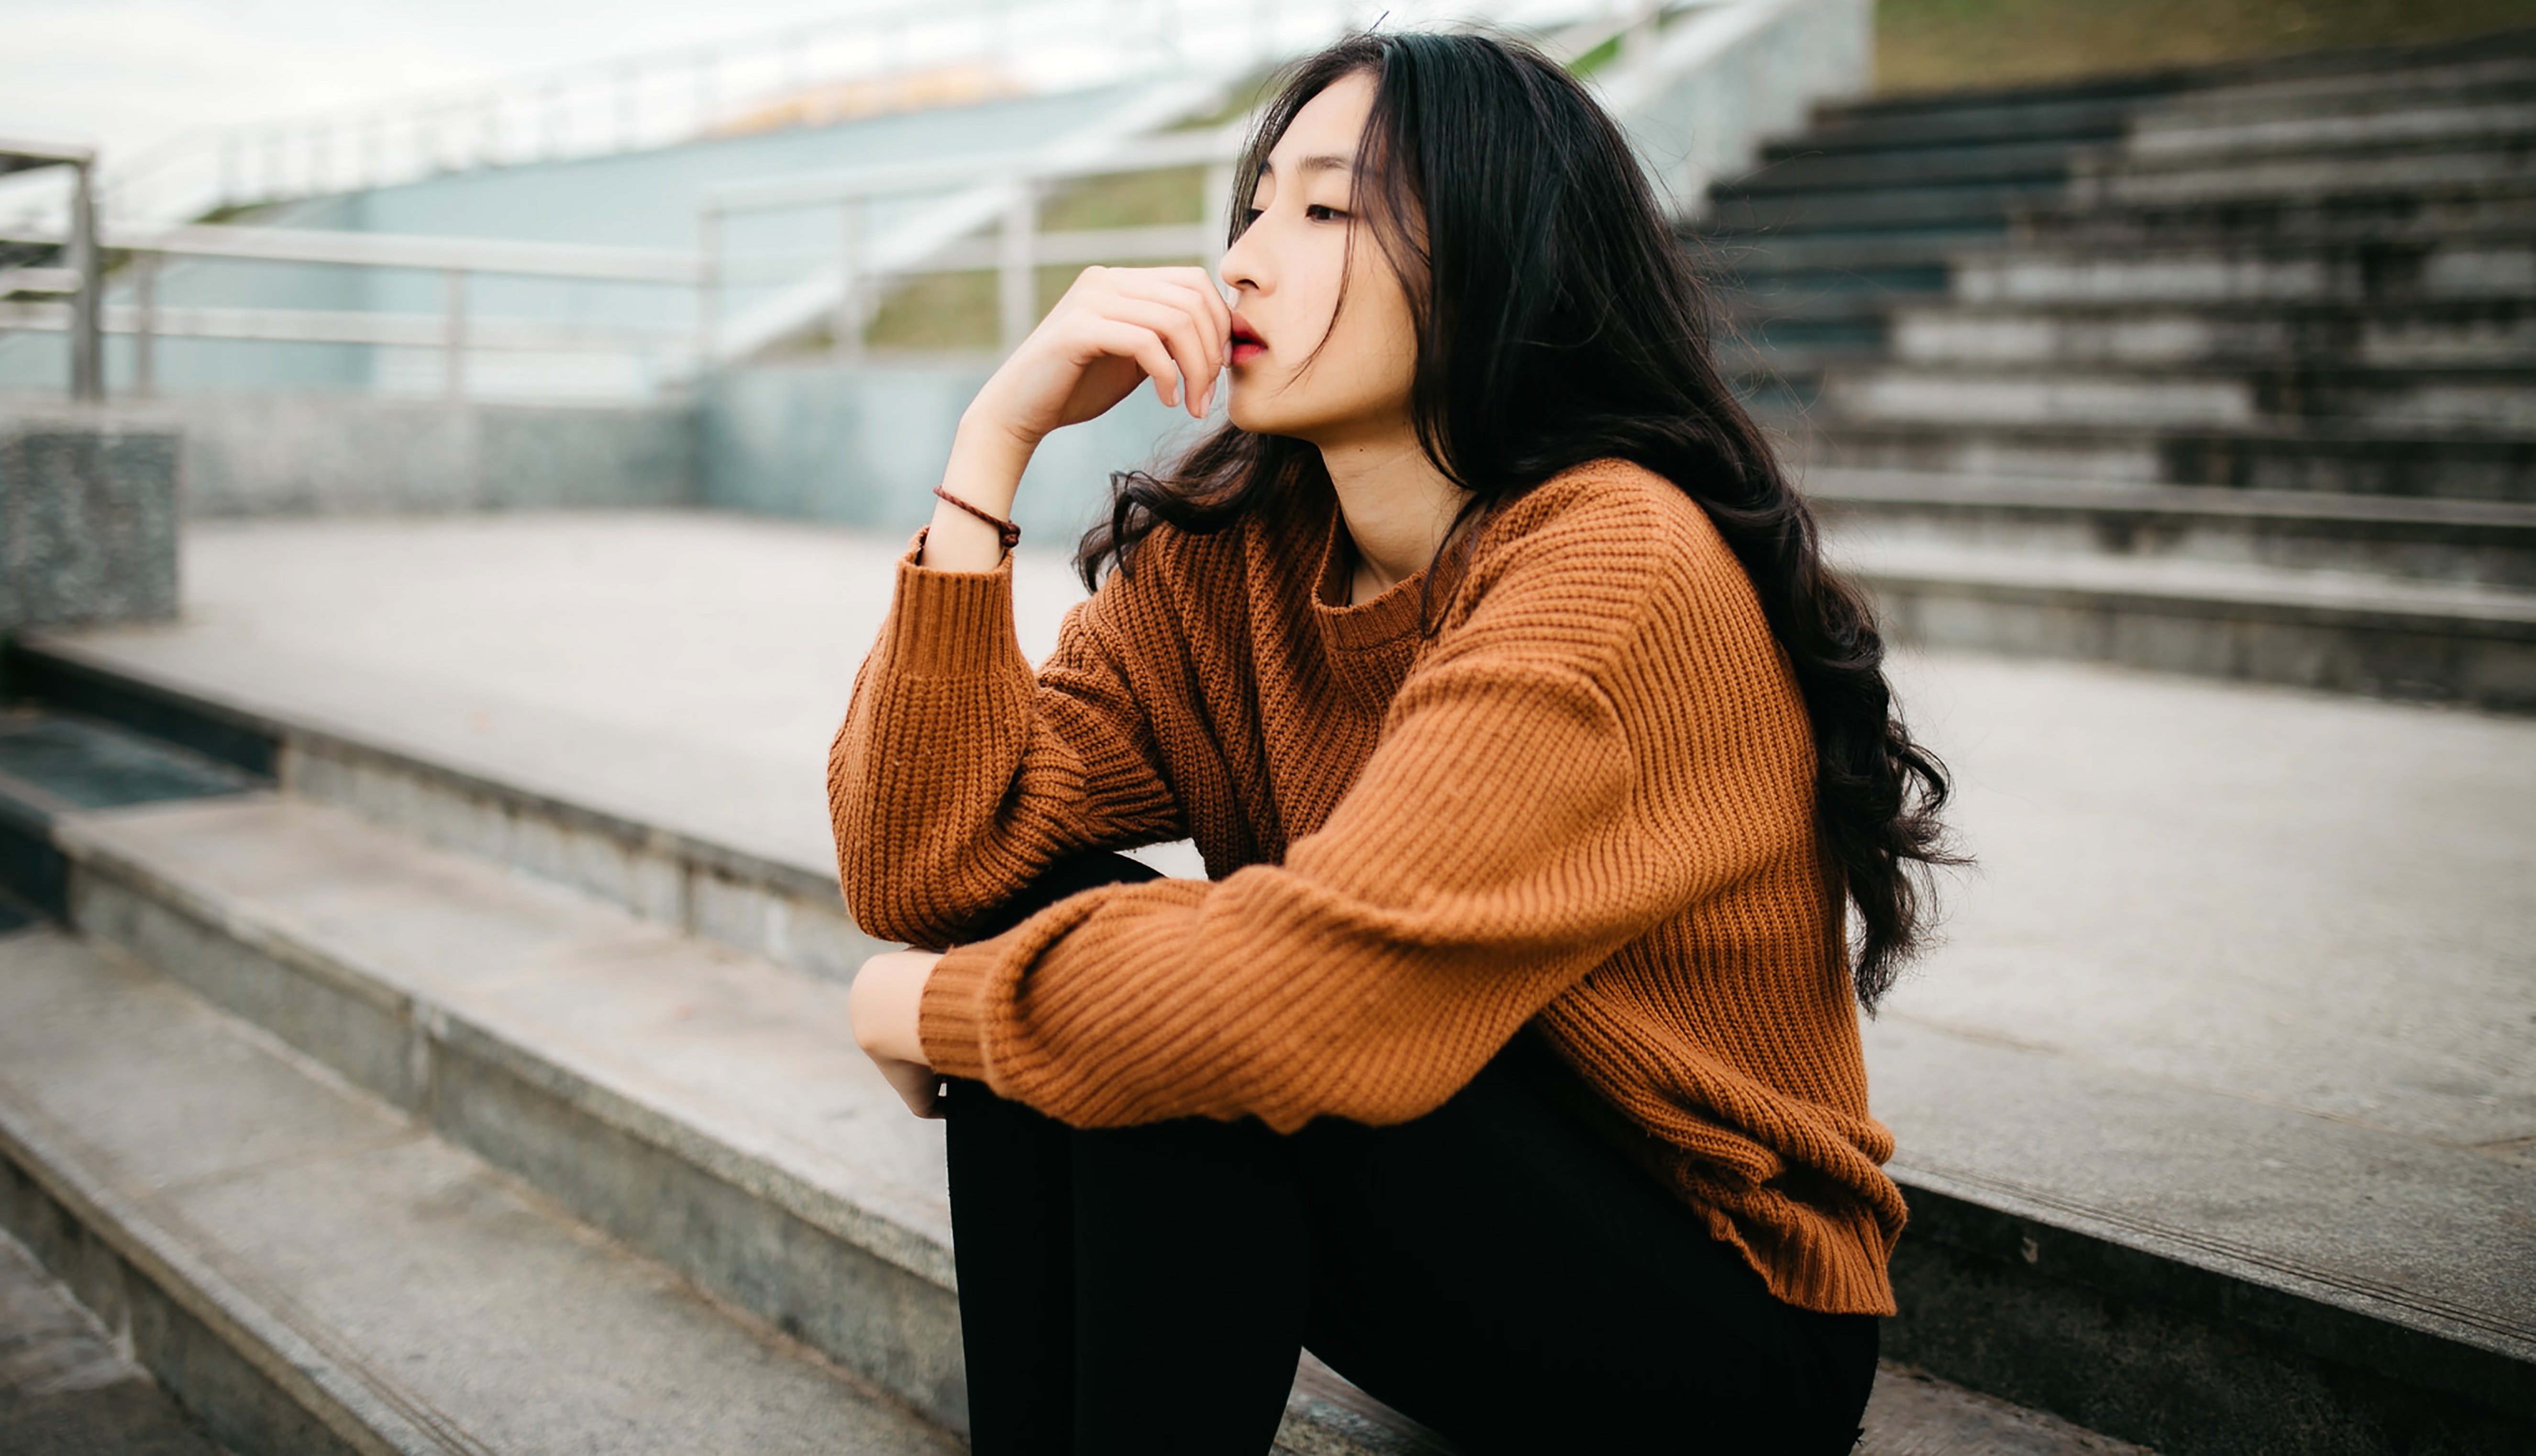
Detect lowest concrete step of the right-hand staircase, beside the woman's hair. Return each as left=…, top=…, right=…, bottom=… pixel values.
left=1841, top=533, right=2536, bottom=713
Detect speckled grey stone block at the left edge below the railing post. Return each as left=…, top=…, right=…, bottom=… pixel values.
left=0, top=411, right=177, bottom=627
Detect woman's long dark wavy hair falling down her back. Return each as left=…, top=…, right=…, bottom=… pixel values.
left=1075, top=31, right=1960, bottom=1010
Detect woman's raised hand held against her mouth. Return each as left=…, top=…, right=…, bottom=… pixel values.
left=961, top=266, right=1232, bottom=446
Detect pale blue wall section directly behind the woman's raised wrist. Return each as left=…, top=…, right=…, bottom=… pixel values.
left=700, top=360, right=1197, bottom=545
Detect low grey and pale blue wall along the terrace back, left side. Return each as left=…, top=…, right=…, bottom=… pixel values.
left=0, top=360, right=1199, bottom=545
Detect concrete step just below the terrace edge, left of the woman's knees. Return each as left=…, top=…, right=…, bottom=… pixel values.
left=58, top=796, right=951, bottom=1283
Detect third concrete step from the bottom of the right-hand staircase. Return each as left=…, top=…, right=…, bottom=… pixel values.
left=1793, top=416, right=2536, bottom=502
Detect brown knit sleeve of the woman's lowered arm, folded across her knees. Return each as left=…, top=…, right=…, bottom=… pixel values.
left=920, top=507, right=1805, bottom=1131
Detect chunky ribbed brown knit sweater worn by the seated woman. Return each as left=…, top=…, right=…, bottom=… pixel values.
left=829, top=462, right=1902, bottom=1314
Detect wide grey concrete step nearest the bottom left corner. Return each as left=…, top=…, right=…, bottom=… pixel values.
left=0, top=931, right=956, bottom=1456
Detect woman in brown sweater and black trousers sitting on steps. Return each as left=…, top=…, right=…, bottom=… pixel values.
left=829, top=33, right=1945, bottom=1456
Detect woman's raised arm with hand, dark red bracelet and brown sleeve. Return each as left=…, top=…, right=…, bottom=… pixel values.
left=829, top=269, right=1230, bottom=944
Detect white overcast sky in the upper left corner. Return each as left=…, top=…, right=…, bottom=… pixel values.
left=0, top=0, right=867, bottom=157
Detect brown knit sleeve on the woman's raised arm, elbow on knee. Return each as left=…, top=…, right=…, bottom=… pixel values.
left=827, top=533, right=1187, bottom=946
